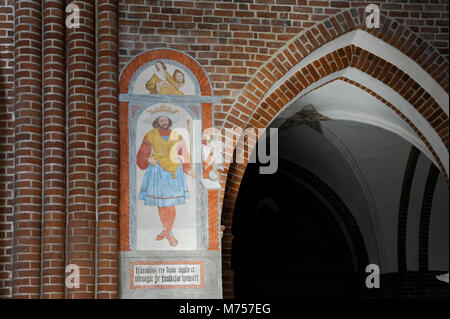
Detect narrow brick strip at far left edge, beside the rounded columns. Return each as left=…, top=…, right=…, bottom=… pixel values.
left=0, top=0, right=14, bottom=299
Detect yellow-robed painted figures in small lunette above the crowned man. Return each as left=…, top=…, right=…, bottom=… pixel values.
left=145, top=61, right=184, bottom=95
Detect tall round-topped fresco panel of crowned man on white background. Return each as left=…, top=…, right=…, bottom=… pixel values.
left=135, top=104, right=197, bottom=250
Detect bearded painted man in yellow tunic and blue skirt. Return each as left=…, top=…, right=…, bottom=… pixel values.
left=136, top=116, right=195, bottom=247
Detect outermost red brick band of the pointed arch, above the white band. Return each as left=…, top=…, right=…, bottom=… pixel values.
left=217, top=8, right=449, bottom=131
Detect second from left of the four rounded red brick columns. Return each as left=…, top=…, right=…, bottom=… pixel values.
left=42, top=0, right=66, bottom=298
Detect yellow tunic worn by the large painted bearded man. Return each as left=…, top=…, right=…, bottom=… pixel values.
left=145, top=128, right=182, bottom=179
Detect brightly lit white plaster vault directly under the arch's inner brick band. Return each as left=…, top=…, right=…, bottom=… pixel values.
left=280, top=77, right=448, bottom=171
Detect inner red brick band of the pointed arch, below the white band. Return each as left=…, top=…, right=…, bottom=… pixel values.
left=224, top=54, right=449, bottom=220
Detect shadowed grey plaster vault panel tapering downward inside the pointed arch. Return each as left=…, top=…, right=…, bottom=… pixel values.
left=327, top=121, right=411, bottom=272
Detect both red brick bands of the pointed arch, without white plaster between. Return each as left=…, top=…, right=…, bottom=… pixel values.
left=219, top=9, right=449, bottom=221
